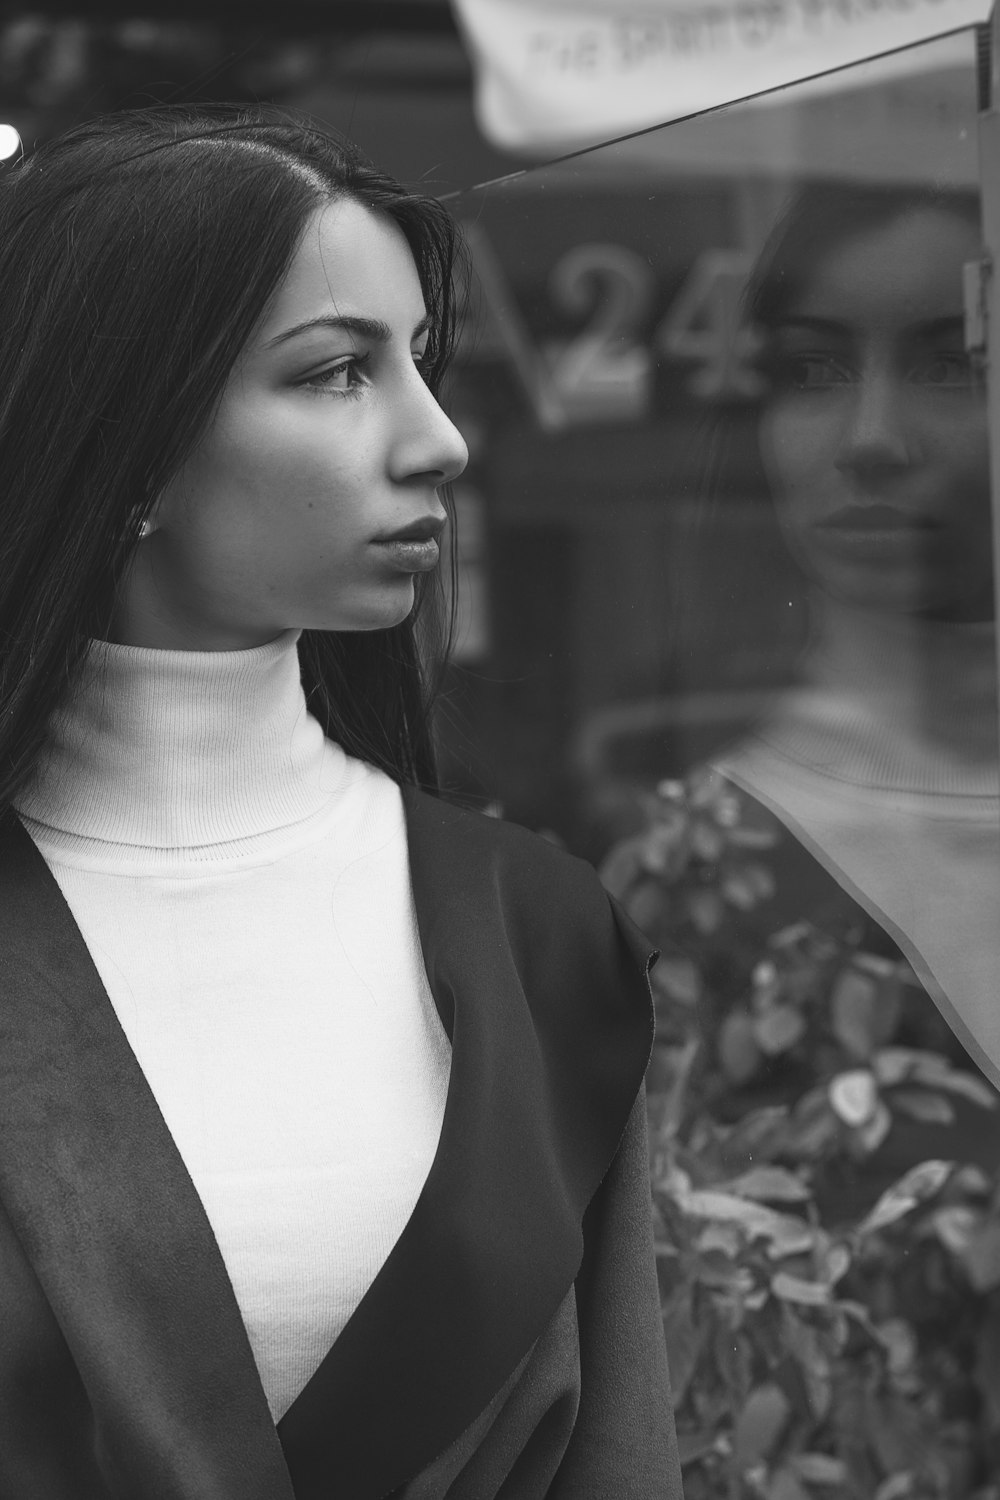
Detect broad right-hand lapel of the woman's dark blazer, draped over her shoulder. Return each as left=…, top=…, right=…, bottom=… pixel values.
left=279, top=789, right=652, bottom=1500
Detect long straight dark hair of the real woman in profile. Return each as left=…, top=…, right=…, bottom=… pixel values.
left=0, top=105, right=460, bottom=807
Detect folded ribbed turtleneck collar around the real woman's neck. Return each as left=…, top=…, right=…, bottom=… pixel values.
left=18, top=630, right=346, bottom=849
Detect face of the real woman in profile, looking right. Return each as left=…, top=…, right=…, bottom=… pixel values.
left=115, top=200, right=466, bottom=651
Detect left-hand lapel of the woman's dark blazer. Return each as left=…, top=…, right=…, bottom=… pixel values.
left=0, top=816, right=292, bottom=1500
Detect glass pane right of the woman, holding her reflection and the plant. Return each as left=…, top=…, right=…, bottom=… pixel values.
left=450, top=33, right=1000, bottom=1496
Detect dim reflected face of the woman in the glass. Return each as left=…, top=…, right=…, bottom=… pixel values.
left=760, top=207, right=993, bottom=620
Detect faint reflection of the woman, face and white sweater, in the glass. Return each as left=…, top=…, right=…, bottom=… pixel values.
left=710, top=188, right=1000, bottom=1079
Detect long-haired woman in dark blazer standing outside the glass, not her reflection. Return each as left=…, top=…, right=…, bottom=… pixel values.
left=0, top=107, right=679, bottom=1500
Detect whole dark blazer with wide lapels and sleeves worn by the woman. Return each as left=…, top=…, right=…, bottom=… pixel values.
left=0, top=791, right=681, bottom=1500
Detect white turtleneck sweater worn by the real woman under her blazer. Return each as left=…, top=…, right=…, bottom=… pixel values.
left=10, top=632, right=450, bottom=1421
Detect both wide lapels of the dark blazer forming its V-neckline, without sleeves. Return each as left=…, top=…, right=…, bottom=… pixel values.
left=0, top=788, right=652, bottom=1500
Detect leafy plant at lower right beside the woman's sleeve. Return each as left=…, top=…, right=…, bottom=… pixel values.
left=603, top=773, right=1000, bottom=1500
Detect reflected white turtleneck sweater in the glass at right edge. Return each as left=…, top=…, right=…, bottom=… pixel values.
left=717, top=596, right=1000, bottom=1086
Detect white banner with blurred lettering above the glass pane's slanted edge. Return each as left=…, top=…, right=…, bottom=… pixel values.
left=454, top=0, right=990, bottom=156
